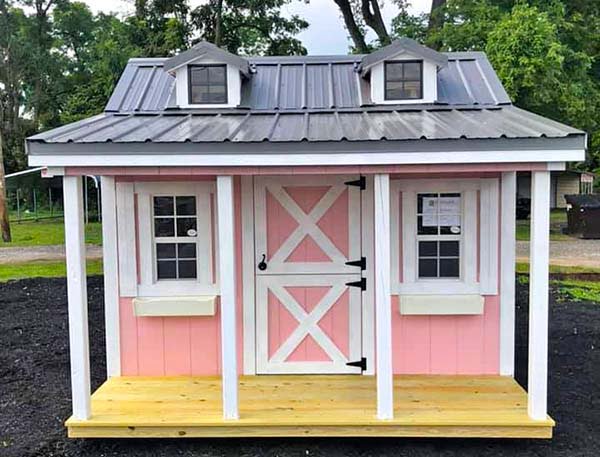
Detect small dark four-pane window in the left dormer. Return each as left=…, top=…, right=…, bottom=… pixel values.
left=188, top=65, right=227, bottom=105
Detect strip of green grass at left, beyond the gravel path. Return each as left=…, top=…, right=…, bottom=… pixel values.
left=0, top=219, right=102, bottom=248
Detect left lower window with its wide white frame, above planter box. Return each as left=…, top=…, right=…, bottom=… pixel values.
left=135, top=181, right=217, bottom=297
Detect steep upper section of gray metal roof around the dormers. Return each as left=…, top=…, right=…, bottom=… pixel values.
left=106, top=52, right=511, bottom=113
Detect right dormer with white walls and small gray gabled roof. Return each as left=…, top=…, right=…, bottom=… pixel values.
left=360, top=38, right=448, bottom=105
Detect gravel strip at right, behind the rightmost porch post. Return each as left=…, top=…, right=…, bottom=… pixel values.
left=517, top=238, right=600, bottom=268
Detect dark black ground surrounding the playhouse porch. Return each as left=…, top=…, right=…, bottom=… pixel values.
left=0, top=277, right=600, bottom=457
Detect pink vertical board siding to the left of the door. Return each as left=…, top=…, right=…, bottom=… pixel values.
left=119, top=178, right=243, bottom=376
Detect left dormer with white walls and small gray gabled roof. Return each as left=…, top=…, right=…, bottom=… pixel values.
left=164, top=41, right=250, bottom=108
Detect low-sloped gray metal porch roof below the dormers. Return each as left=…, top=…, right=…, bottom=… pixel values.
left=29, top=107, right=582, bottom=143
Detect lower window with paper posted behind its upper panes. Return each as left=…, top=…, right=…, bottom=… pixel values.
left=416, top=193, right=462, bottom=279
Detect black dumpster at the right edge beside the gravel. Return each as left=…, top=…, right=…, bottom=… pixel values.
left=565, top=194, right=600, bottom=239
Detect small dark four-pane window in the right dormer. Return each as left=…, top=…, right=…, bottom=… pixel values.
left=384, top=61, right=423, bottom=100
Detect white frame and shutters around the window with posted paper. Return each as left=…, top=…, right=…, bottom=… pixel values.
left=390, top=178, right=499, bottom=295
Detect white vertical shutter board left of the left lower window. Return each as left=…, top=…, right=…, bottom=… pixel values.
left=116, top=182, right=138, bottom=297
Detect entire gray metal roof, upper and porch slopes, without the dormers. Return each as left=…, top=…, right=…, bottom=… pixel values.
left=28, top=46, right=585, bottom=154
